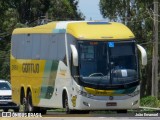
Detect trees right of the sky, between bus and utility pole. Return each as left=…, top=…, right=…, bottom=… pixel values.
left=99, top=0, right=160, bottom=96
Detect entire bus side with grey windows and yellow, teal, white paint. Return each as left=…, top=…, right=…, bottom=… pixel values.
left=11, top=33, right=73, bottom=107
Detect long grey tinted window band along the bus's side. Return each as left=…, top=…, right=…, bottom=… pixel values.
left=12, top=34, right=66, bottom=60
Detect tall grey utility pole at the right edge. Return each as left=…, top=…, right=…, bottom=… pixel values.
left=152, top=0, right=158, bottom=98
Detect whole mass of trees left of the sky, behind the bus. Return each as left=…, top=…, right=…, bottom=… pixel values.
left=0, top=0, right=84, bottom=80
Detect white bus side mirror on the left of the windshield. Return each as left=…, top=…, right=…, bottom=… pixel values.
left=70, top=45, right=78, bottom=66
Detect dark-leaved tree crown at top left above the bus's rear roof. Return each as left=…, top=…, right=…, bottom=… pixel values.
left=5, top=0, right=51, bottom=24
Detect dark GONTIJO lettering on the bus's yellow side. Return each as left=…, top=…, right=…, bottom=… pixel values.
left=22, top=63, right=39, bottom=73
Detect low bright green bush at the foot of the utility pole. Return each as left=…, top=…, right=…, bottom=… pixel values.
left=140, top=96, right=160, bottom=107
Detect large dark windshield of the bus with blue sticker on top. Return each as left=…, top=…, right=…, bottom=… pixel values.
left=78, top=41, right=138, bottom=88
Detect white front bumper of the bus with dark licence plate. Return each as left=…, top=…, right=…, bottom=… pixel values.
left=72, top=95, right=140, bottom=110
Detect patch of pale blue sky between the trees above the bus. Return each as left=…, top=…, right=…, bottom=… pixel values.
left=78, top=0, right=103, bottom=20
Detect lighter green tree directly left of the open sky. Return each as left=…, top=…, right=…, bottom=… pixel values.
left=49, top=0, right=84, bottom=20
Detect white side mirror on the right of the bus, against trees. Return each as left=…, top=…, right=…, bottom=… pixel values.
left=137, top=44, right=147, bottom=65
